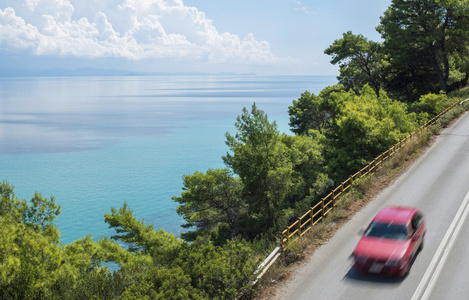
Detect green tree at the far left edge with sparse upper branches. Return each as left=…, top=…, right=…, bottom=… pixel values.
left=0, top=181, right=62, bottom=299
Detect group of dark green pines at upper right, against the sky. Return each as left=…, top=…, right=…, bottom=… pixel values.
left=325, top=0, right=469, bottom=102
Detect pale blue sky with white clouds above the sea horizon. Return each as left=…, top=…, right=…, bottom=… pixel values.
left=0, top=0, right=391, bottom=75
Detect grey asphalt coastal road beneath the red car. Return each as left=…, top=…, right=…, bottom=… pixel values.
left=277, top=113, right=469, bottom=300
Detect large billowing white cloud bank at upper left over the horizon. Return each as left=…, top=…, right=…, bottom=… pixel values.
left=0, top=0, right=278, bottom=63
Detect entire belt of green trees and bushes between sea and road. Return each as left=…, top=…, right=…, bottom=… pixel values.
left=0, top=0, right=469, bottom=299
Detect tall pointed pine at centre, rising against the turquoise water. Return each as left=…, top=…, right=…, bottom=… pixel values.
left=223, top=104, right=293, bottom=237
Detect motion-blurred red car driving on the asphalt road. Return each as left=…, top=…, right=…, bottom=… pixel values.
left=352, top=206, right=426, bottom=278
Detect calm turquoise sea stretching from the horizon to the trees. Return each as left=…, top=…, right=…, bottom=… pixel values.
left=0, top=75, right=337, bottom=244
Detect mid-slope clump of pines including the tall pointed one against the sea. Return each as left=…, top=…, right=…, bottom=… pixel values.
left=173, top=104, right=331, bottom=243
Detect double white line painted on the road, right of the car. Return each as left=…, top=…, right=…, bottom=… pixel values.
left=412, top=191, right=469, bottom=300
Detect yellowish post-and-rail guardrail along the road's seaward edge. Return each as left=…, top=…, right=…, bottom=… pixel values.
left=281, top=99, right=460, bottom=250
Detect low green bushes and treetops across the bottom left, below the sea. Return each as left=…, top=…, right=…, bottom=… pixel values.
left=0, top=181, right=257, bottom=300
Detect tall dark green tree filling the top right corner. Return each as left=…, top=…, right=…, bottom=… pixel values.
left=377, top=0, right=469, bottom=99
